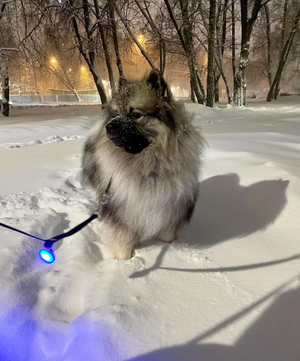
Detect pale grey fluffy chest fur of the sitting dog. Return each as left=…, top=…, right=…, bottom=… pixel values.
left=97, top=145, right=195, bottom=241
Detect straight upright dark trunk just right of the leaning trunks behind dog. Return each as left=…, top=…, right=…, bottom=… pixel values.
left=206, top=0, right=216, bottom=108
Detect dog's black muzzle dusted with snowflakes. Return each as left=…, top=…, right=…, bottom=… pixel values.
left=106, top=115, right=149, bottom=154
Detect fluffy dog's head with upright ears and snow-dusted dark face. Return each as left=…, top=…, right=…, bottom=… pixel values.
left=106, top=70, right=175, bottom=154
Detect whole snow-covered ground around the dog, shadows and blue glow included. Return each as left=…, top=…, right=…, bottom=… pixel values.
left=0, top=96, right=300, bottom=361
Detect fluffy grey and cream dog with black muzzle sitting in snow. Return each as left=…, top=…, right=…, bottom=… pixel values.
left=82, top=70, right=204, bottom=260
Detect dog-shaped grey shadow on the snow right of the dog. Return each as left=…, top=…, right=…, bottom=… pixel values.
left=181, top=174, right=289, bottom=248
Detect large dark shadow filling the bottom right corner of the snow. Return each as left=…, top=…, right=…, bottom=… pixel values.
left=127, top=275, right=300, bottom=361
